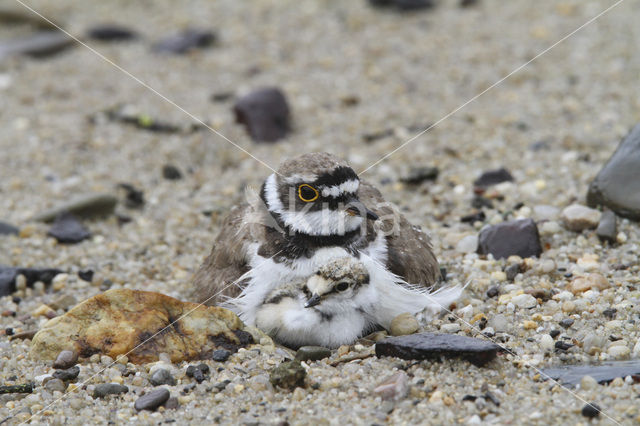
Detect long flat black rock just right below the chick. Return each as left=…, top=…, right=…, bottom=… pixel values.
left=376, top=333, right=500, bottom=366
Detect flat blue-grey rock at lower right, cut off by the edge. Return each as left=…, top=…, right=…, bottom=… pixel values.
left=542, top=359, right=640, bottom=386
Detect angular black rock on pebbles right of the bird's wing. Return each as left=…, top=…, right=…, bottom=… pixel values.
left=478, top=219, right=542, bottom=259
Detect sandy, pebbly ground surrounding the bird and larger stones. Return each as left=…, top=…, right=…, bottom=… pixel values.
left=0, top=0, right=640, bottom=424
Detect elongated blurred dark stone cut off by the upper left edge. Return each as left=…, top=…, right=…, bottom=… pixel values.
left=0, top=30, right=74, bottom=60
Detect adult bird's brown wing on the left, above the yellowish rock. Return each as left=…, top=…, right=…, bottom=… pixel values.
left=188, top=204, right=252, bottom=305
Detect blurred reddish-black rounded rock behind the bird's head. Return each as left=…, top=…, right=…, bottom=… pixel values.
left=233, top=87, right=290, bottom=142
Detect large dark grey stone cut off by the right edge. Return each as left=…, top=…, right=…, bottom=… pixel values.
left=587, top=124, right=640, bottom=220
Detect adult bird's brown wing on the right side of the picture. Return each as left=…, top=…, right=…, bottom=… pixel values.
left=358, top=181, right=440, bottom=287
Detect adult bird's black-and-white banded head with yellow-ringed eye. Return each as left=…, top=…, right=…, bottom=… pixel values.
left=260, top=152, right=378, bottom=236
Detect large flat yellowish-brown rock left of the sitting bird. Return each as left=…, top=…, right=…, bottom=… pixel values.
left=31, top=289, right=263, bottom=364
